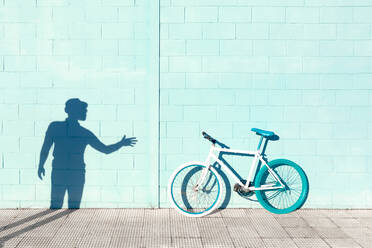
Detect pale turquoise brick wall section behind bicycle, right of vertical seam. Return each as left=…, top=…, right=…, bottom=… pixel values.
left=160, top=0, right=372, bottom=208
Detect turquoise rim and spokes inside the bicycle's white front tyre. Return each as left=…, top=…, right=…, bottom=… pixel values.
left=171, top=165, right=221, bottom=215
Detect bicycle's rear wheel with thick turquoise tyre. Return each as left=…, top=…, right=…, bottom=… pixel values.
left=255, top=159, right=309, bottom=214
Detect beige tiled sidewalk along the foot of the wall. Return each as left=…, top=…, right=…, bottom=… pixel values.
left=0, top=209, right=372, bottom=248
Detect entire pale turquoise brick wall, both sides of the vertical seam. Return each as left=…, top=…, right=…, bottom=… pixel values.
left=0, top=0, right=372, bottom=208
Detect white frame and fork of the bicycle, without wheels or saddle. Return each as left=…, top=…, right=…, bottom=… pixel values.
left=195, top=139, right=285, bottom=191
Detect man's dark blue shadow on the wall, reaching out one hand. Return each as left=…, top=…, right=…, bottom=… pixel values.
left=38, top=98, right=137, bottom=209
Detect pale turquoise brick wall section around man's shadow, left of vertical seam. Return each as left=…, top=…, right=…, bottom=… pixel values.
left=0, top=0, right=159, bottom=208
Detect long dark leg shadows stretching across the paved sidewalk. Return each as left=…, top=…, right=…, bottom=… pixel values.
left=0, top=209, right=77, bottom=248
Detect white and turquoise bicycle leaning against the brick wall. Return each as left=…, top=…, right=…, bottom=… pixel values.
left=168, top=128, right=309, bottom=217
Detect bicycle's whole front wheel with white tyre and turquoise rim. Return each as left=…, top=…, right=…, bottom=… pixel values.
left=168, top=162, right=222, bottom=217
